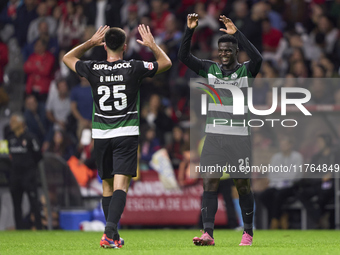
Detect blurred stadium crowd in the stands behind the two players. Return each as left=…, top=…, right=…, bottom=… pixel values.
left=0, top=0, right=340, bottom=228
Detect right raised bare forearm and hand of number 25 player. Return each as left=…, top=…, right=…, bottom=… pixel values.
left=137, top=24, right=172, bottom=74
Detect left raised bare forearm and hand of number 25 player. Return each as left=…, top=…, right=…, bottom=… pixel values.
left=63, top=26, right=110, bottom=72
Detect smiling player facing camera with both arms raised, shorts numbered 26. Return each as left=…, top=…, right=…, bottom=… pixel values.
left=178, top=13, right=262, bottom=246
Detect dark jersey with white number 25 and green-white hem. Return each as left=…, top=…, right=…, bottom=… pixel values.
left=76, top=60, right=158, bottom=139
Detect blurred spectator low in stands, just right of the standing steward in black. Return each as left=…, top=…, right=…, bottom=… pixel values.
left=47, top=130, right=74, bottom=161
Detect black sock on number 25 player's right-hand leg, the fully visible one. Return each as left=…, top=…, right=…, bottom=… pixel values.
left=104, top=190, right=126, bottom=240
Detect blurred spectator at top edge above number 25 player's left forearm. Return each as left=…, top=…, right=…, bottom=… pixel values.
left=58, top=1, right=86, bottom=48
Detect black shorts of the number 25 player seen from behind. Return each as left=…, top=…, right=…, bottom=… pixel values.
left=94, top=136, right=138, bottom=179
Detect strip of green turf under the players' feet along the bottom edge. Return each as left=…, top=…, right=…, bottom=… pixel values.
left=0, top=230, right=340, bottom=255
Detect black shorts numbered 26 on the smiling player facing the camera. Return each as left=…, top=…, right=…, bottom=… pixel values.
left=200, top=134, right=251, bottom=179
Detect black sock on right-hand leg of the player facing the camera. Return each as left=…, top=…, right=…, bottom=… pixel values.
left=240, top=191, right=254, bottom=236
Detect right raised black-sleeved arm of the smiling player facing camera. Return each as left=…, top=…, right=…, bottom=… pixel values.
left=220, top=15, right=262, bottom=76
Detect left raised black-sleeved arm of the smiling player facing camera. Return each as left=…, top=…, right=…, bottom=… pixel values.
left=178, top=13, right=207, bottom=74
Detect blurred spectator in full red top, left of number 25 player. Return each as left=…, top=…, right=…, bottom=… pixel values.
left=24, top=39, right=54, bottom=101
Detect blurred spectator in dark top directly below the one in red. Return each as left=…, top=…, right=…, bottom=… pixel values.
left=24, top=95, right=48, bottom=145
